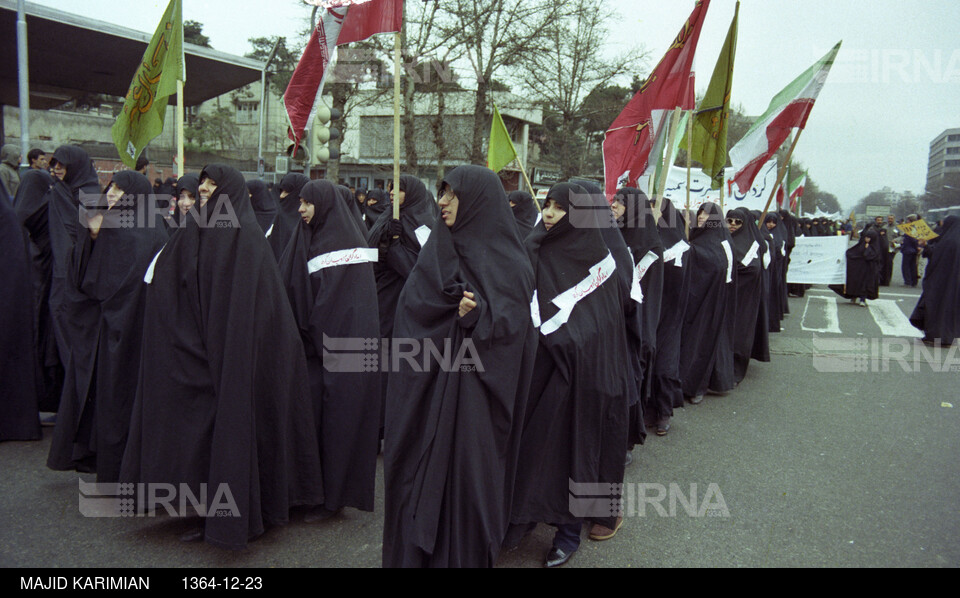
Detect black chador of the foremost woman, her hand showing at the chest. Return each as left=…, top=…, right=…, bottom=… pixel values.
left=383, top=166, right=537, bottom=567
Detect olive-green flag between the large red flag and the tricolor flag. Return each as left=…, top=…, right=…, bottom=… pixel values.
left=682, top=2, right=740, bottom=189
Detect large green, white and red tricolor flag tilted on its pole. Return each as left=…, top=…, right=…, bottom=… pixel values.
left=730, top=42, right=843, bottom=189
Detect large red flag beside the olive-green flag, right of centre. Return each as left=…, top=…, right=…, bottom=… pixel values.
left=603, top=0, right=710, bottom=195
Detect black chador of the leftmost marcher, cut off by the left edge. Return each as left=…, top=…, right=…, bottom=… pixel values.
left=0, top=184, right=41, bottom=442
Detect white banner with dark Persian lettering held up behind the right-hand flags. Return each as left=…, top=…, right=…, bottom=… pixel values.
left=637, top=159, right=786, bottom=212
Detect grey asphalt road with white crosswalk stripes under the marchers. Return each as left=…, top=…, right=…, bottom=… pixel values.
left=0, top=254, right=960, bottom=568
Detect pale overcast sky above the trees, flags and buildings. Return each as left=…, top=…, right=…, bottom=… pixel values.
left=35, top=0, right=960, bottom=207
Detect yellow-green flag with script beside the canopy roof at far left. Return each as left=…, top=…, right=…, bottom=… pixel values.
left=112, top=0, right=186, bottom=168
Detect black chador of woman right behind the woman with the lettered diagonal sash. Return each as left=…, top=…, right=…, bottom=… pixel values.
left=614, top=188, right=664, bottom=445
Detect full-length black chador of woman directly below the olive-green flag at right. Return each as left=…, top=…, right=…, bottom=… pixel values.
left=680, top=203, right=737, bottom=397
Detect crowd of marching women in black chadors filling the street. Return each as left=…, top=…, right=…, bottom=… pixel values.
left=0, top=146, right=960, bottom=567
